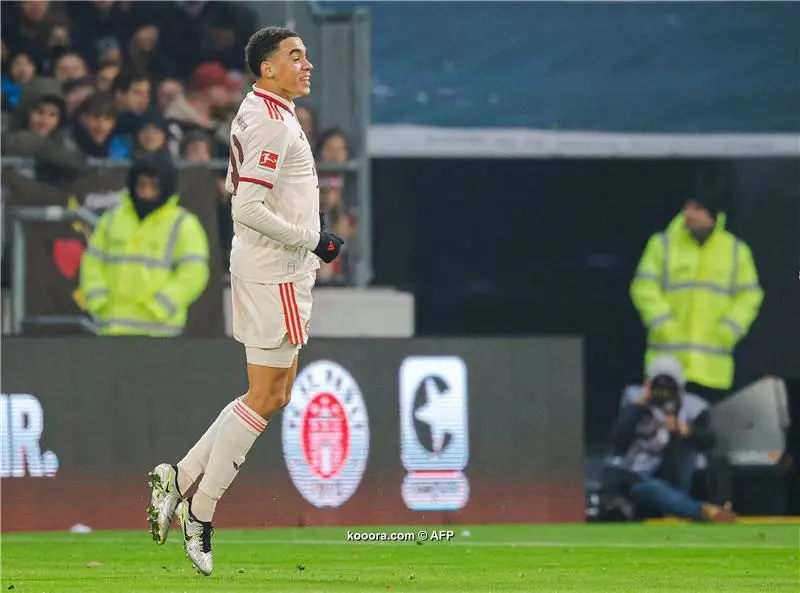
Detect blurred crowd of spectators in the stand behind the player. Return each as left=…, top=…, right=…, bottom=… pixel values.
left=1, top=0, right=354, bottom=283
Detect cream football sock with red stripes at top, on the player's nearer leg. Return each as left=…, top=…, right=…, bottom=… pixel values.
left=190, top=400, right=267, bottom=521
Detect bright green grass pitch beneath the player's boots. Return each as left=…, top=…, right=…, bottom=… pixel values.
left=0, top=524, right=800, bottom=593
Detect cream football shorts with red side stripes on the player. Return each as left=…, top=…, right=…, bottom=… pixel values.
left=231, top=271, right=316, bottom=368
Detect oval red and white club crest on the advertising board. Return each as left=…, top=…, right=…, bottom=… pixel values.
left=282, top=360, right=369, bottom=508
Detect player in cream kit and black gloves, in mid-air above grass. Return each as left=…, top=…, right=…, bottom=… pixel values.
left=148, top=27, right=343, bottom=576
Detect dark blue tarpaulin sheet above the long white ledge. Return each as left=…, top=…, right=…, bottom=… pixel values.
left=326, top=1, right=800, bottom=133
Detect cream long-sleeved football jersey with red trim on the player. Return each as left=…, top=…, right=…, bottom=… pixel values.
left=225, top=86, right=320, bottom=283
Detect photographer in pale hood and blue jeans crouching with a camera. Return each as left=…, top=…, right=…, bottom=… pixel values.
left=602, top=356, right=736, bottom=522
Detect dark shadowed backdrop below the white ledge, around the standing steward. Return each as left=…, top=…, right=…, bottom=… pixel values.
left=372, top=159, right=800, bottom=439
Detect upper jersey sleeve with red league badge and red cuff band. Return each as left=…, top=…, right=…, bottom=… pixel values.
left=225, top=120, right=290, bottom=194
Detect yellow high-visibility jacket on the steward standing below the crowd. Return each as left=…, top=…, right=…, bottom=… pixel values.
left=80, top=195, right=209, bottom=337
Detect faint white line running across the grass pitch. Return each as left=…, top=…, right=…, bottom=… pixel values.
left=0, top=535, right=799, bottom=551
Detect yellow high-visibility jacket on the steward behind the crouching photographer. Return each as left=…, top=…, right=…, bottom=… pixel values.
left=630, top=213, right=764, bottom=389
